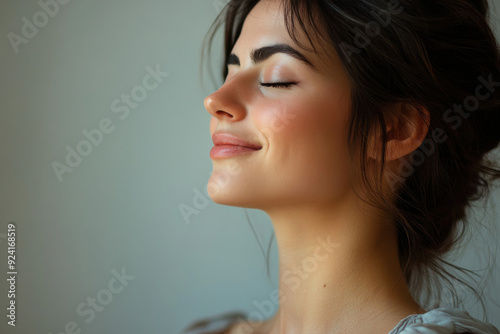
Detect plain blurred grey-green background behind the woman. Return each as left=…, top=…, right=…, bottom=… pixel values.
left=0, top=0, right=500, bottom=334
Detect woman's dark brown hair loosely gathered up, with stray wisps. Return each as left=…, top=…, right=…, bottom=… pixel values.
left=188, top=0, right=500, bottom=332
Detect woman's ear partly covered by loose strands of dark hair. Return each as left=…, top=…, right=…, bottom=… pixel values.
left=368, top=102, right=430, bottom=161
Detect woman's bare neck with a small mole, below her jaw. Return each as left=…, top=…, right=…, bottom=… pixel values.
left=260, top=189, right=423, bottom=334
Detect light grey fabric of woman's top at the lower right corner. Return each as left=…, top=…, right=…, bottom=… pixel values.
left=389, top=307, right=500, bottom=334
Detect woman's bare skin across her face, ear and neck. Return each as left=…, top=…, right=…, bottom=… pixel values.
left=205, top=0, right=428, bottom=334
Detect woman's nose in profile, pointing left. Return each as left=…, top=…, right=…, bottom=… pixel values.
left=204, top=80, right=246, bottom=122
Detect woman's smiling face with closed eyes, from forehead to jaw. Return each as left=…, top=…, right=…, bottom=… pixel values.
left=205, top=0, right=351, bottom=210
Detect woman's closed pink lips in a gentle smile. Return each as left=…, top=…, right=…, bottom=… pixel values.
left=210, top=132, right=262, bottom=159
